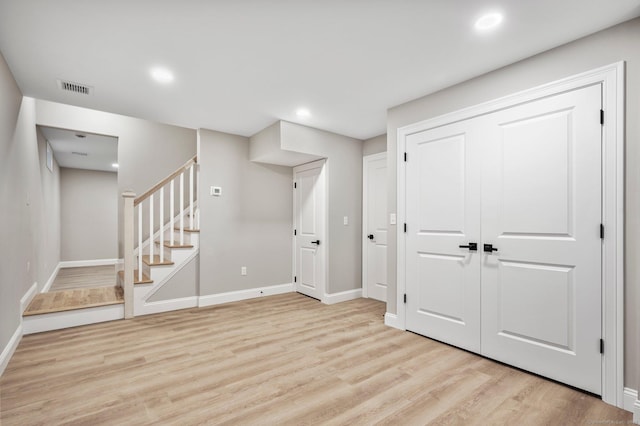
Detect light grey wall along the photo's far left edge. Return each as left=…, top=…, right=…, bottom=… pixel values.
left=0, top=51, right=60, bottom=363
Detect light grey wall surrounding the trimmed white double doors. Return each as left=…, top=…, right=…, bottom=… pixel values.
left=387, top=18, right=640, bottom=389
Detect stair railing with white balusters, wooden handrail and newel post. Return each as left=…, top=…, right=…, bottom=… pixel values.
left=122, top=157, right=199, bottom=318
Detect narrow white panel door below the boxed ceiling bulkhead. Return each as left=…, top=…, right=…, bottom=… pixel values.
left=293, top=160, right=326, bottom=300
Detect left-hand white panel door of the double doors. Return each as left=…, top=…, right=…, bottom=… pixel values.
left=398, top=122, right=480, bottom=352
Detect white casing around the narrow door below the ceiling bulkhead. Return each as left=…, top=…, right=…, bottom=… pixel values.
left=291, top=158, right=329, bottom=303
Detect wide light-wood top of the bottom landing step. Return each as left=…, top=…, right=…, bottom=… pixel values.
left=22, top=286, right=124, bottom=317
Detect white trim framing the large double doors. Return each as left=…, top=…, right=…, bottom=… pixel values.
left=394, top=62, right=625, bottom=407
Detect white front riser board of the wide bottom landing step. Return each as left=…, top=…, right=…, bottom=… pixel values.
left=22, top=304, right=124, bottom=334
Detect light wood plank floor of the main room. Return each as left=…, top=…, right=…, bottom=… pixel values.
left=0, top=294, right=631, bottom=426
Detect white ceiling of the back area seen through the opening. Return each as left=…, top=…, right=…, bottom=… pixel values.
left=39, top=126, right=118, bottom=172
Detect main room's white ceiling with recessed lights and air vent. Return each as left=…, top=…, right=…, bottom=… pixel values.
left=0, top=0, right=640, bottom=139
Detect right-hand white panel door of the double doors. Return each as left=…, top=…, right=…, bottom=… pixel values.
left=481, top=85, right=601, bottom=394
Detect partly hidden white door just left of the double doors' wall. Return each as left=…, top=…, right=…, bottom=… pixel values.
left=362, top=152, right=388, bottom=302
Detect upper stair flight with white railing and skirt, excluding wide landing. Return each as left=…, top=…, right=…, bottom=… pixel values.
left=118, top=157, right=200, bottom=318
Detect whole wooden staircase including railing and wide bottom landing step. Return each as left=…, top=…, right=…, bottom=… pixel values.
left=23, top=157, right=200, bottom=334
